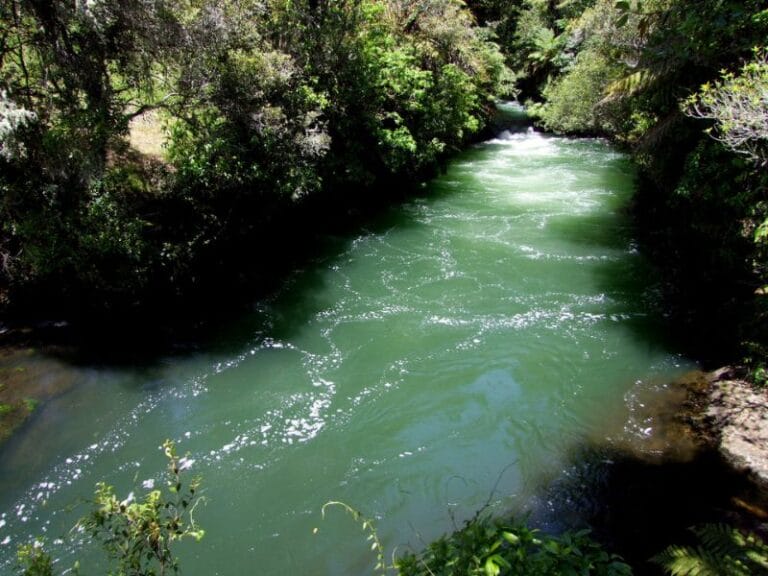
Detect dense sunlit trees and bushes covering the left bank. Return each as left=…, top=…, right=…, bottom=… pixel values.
left=0, top=0, right=505, bottom=336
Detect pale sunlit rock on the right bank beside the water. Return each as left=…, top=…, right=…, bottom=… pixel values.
left=706, top=369, right=768, bottom=488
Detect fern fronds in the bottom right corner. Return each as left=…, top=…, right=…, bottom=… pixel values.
left=653, top=524, right=768, bottom=576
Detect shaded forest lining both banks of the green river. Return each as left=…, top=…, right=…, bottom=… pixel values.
left=0, top=0, right=768, bottom=368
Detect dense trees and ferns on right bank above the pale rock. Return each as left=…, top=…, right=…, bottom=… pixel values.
left=468, top=0, right=768, bottom=368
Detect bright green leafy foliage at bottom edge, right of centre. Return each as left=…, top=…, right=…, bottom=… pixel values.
left=396, top=518, right=631, bottom=576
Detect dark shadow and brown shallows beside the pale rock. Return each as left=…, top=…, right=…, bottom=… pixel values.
left=530, top=364, right=768, bottom=576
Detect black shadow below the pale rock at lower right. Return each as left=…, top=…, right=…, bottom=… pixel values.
left=532, top=438, right=767, bottom=576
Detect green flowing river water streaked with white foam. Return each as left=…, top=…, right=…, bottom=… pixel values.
left=0, top=107, right=690, bottom=576
